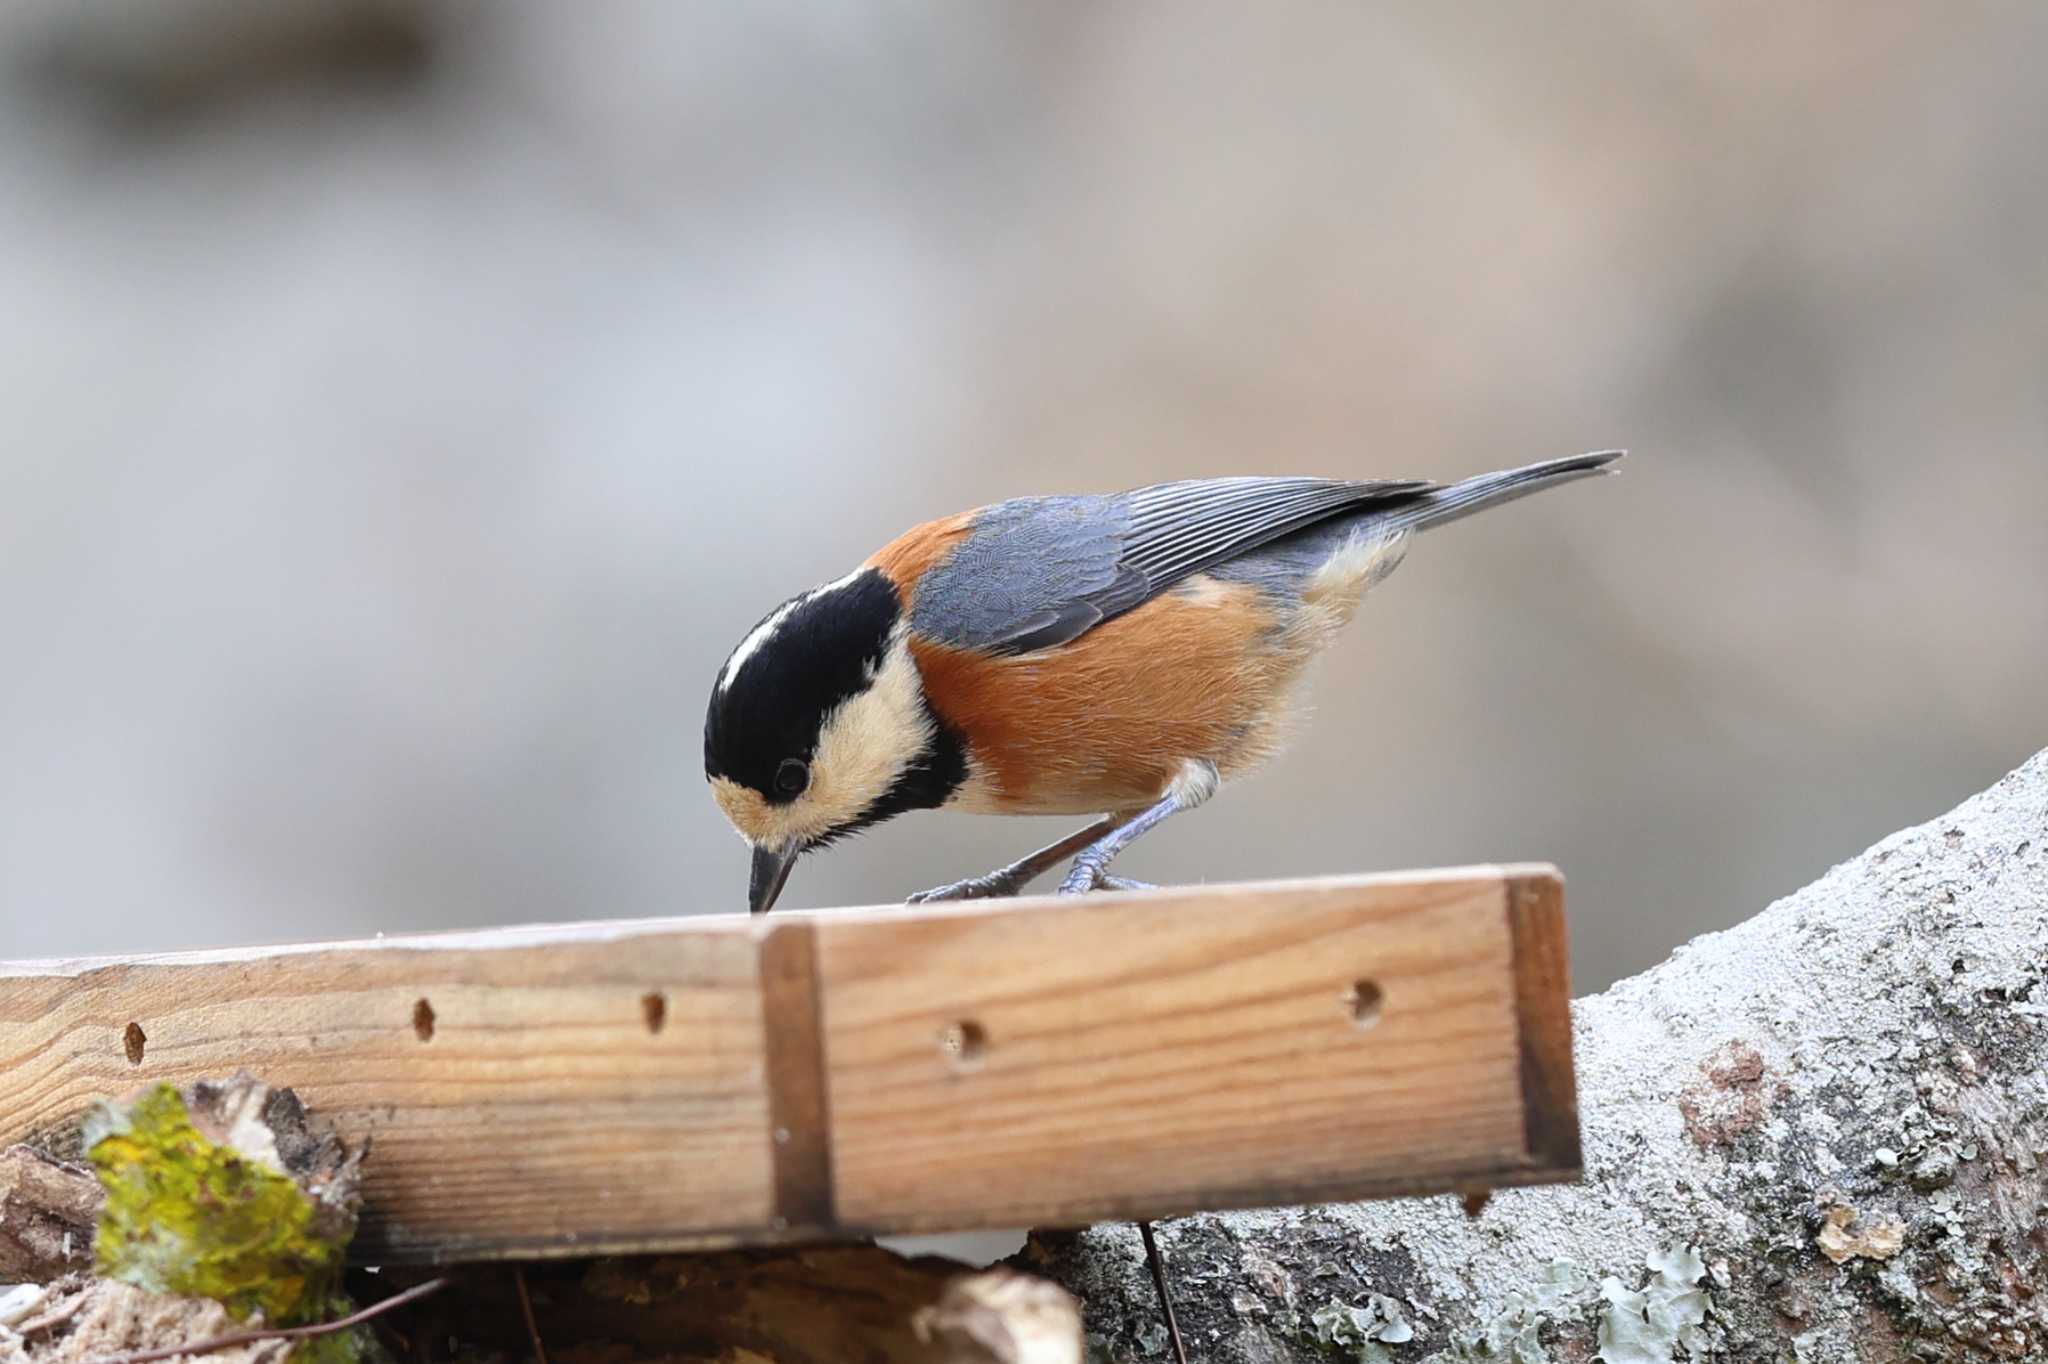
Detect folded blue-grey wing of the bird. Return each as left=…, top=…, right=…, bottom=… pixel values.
left=911, top=477, right=1434, bottom=653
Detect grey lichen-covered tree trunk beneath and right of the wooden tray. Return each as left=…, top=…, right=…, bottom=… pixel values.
left=1028, top=754, right=2048, bottom=1364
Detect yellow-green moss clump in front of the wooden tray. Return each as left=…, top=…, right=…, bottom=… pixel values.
left=86, top=1085, right=360, bottom=1364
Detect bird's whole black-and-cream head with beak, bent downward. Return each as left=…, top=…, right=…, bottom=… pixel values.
left=705, top=567, right=967, bottom=913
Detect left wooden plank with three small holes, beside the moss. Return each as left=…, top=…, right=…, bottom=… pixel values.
left=0, top=920, right=774, bottom=1260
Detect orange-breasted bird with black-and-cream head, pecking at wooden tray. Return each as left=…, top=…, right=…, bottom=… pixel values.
left=705, top=451, right=1622, bottom=913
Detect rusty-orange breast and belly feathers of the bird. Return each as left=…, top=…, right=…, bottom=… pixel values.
left=911, top=578, right=1307, bottom=815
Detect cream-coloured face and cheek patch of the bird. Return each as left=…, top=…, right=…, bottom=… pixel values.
left=711, top=629, right=932, bottom=852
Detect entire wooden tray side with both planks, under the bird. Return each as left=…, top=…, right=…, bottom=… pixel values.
left=0, top=866, right=1579, bottom=1264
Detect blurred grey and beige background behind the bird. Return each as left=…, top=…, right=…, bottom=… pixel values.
left=0, top=0, right=2048, bottom=989
